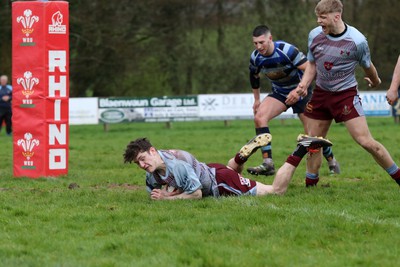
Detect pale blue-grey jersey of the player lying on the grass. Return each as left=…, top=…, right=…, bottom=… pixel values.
left=146, top=150, right=219, bottom=196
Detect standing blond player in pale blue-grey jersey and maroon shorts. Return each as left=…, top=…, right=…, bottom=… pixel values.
left=286, top=0, right=400, bottom=186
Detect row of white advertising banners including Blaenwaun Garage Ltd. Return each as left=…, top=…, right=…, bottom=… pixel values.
left=69, top=91, right=391, bottom=125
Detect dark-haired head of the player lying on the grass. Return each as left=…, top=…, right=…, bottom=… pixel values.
left=124, top=138, right=162, bottom=172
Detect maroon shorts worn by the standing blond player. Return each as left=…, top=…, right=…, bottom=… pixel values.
left=304, top=86, right=364, bottom=122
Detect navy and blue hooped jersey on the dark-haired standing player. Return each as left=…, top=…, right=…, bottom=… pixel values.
left=249, top=41, right=307, bottom=97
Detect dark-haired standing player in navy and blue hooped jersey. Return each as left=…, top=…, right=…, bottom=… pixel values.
left=247, top=25, right=340, bottom=175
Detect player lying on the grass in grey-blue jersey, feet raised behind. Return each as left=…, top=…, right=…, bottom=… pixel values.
left=123, top=134, right=332, bottom=200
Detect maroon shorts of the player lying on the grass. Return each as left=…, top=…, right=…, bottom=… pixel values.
left=207, top=163, right=257, bottom=196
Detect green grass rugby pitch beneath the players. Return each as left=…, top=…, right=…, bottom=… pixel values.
left=0, top=118, right=400, bottom=266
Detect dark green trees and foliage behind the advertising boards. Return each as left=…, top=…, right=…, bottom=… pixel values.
left=0, top=0, right=400, bottom=96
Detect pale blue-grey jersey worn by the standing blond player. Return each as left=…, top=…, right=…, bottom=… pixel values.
left=307, top=25, right=371, bottom=92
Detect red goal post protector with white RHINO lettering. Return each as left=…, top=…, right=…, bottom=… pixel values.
left=12, top=1, right=69, bottom=178
